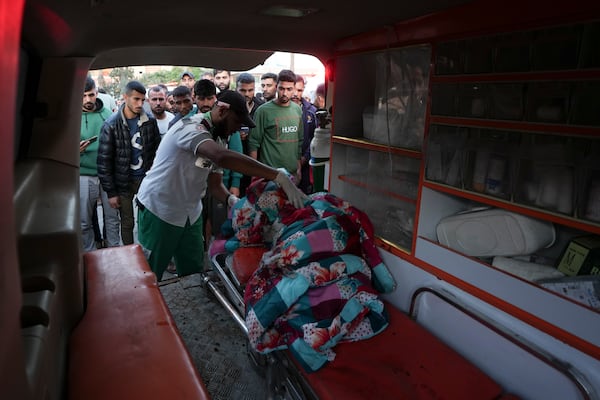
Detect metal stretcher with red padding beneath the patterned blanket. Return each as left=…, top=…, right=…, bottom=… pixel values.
left=205, top=248, right=517, bottom=400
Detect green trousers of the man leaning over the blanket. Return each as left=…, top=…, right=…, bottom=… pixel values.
left=138, top=207, right=204, bottom=281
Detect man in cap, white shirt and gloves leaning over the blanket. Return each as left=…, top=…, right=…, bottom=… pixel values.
left=137, top=90, right=306, bottom=280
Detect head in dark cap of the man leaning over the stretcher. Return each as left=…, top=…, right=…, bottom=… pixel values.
left=211, top=90, right=256, bottom=137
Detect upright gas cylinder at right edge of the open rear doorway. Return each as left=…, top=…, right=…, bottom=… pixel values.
left=308, top=111, right=331, bottom=192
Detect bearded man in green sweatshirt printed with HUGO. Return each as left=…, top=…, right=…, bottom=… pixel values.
left=248, top=69, right=304, bottom=184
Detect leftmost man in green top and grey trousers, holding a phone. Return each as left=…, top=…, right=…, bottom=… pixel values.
left=79, top=76, right=121, bottom=251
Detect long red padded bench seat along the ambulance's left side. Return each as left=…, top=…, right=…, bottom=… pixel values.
left=68, top=245, right=210, bottom=400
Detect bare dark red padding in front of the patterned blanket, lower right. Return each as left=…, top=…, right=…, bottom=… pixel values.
left=302, top=304, right=503, bottom=400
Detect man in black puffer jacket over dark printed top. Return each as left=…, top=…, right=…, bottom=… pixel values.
left=98, top=81, right=160, bottom=244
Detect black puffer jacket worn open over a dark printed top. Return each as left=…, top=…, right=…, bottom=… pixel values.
left=98, top=105, right=160, bottom=197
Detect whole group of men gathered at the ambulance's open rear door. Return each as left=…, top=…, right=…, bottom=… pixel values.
left=79, top=69, right=324, bottom=280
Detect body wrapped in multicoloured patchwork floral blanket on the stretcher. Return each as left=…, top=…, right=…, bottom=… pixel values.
left=224, top=180, right=395, bottom=371
